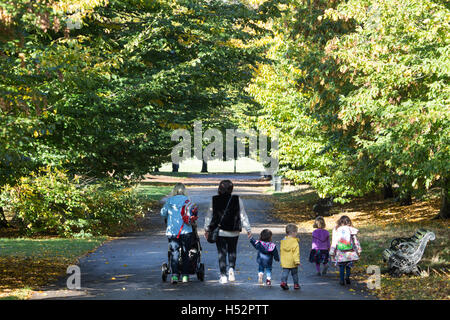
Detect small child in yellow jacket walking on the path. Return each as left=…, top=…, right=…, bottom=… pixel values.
left=280, top=223, right=301, bottom=290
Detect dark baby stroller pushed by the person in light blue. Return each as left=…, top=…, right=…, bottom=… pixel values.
left=161, top=223, right=205, bottom=282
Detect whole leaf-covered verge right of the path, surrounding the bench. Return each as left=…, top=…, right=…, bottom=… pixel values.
left=265, top=186, right=450, bottom=300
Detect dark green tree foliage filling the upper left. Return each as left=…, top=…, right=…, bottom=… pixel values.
left=0, top=0, right=267, bottom=185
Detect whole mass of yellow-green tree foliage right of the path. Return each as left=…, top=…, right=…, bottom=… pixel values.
left=244, top=0, right=450, bottom=201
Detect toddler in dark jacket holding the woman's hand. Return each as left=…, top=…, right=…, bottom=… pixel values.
left=250, top=229, right=280, bottom=286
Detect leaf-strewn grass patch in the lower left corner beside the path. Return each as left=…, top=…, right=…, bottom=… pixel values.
left=0, top=237, right=107, bottom=299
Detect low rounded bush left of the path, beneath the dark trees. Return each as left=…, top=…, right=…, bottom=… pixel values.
left=0, top=168, right=142, bottom=237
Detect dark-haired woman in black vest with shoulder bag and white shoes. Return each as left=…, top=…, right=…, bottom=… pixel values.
left=205, top=180, right=252, bottom=284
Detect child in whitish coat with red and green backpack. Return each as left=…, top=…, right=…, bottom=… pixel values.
left=330, top=216, right=362, bottom=285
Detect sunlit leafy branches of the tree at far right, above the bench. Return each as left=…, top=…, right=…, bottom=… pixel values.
left=331, top=0, right=450, bottom=198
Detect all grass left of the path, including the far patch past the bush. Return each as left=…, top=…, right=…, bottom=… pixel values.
left=0, top=184, right=173, bottom=300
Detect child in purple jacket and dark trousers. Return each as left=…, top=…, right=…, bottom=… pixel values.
left=309, top=216, right=330, bottom=276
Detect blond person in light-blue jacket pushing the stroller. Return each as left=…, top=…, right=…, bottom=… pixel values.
left=161, top=183, right=198, bottom=284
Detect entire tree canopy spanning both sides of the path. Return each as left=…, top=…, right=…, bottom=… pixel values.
left=0, top=0, right=450, bottom=215
